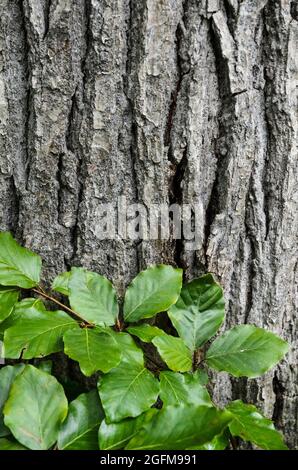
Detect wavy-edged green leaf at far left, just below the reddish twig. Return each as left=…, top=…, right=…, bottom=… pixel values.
left=4, top=304, right=79, bottom=359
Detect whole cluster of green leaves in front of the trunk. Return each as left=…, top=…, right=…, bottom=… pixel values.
left=0, top=232, right=288, bottom=450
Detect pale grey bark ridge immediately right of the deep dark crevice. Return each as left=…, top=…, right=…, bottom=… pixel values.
left=171, top=1, right=218, bottom=276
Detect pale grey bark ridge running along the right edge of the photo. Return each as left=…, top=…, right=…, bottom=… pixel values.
left=254, top=1, right=298, bottom=445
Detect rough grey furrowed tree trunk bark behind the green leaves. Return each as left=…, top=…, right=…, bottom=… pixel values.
left=0, top=0, right=298, bottom=447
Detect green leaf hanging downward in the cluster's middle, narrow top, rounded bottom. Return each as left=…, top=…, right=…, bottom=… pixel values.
left=98, top=335, right=159, bottom=422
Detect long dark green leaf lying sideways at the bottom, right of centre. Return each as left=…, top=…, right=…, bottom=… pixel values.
left=126, top=405, right=231, bottom=450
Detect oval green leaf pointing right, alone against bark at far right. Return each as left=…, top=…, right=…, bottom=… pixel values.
left=206, top=325, right=288, bottom=377
